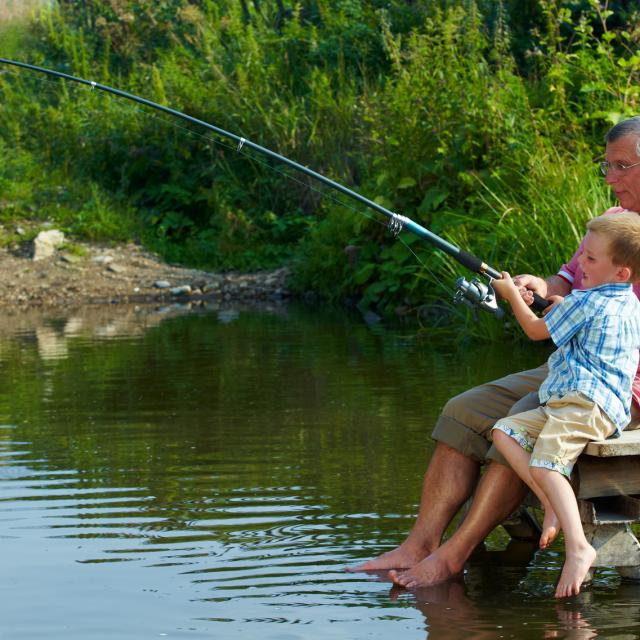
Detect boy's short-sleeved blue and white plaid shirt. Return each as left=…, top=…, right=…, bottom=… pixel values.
left=539, top=283, right=640, bottom=435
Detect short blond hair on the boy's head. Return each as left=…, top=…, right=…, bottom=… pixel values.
left=587, top=211, right=640, bottom=282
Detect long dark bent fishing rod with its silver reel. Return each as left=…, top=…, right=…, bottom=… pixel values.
left=0, top=58, right=549, bottom=317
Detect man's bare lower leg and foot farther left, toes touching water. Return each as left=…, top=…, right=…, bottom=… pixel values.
left=350, top=442, right=480, bottom=571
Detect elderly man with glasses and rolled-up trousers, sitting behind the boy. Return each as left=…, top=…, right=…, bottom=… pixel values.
left=352, top=116, right=640, bottom=588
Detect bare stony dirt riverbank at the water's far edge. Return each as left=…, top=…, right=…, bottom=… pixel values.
left=0, top=242, right=290, bottom=308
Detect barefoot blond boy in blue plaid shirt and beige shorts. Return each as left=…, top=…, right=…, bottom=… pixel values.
left=492, top=212, right=640, bottom=598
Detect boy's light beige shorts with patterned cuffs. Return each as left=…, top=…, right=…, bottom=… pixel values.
left=494, top=393, right=616, bottom=478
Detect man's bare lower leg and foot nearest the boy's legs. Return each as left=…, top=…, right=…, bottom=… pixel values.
left=389, top=462, right=528, bottom=588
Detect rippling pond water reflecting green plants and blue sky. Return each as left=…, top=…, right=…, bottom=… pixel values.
left=0, top=307, right=640, bottom=640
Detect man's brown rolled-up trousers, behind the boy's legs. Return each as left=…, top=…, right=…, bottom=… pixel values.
left=432, top=363, right=640, bottom=465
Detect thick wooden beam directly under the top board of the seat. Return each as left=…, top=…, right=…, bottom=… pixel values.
left=571, top=456, right=640, bottom=498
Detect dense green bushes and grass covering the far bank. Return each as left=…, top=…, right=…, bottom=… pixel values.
left=0, top=0, right=640, bottom=332
